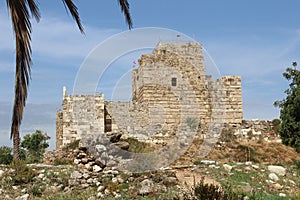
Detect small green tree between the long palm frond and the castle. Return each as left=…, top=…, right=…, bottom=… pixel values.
left=21, top=130, right=50, bottom=163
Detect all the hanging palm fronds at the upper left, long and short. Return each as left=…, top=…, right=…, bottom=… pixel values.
left=6, top=0, right=132, bottom=160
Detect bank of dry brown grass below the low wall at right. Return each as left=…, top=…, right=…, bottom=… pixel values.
left=173, top=139, right=300, bottom=165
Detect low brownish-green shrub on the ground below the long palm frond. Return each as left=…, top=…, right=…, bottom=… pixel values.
left=9, top=160, right=36, bottom=184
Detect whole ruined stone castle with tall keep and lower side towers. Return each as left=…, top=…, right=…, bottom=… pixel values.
left=56, top=42, right=243, bottom=148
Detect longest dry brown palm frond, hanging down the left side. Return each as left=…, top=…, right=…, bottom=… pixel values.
left=6, top=0, right=33, bottom=138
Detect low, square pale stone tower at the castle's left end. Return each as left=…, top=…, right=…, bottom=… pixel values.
left=57, top=94, right=104, bottom=147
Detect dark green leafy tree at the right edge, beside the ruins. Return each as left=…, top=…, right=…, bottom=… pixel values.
left=274, top=62, right=300, bottom=152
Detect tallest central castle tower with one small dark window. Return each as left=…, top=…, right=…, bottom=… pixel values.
left=132, top=43, right=210, bottom=130
